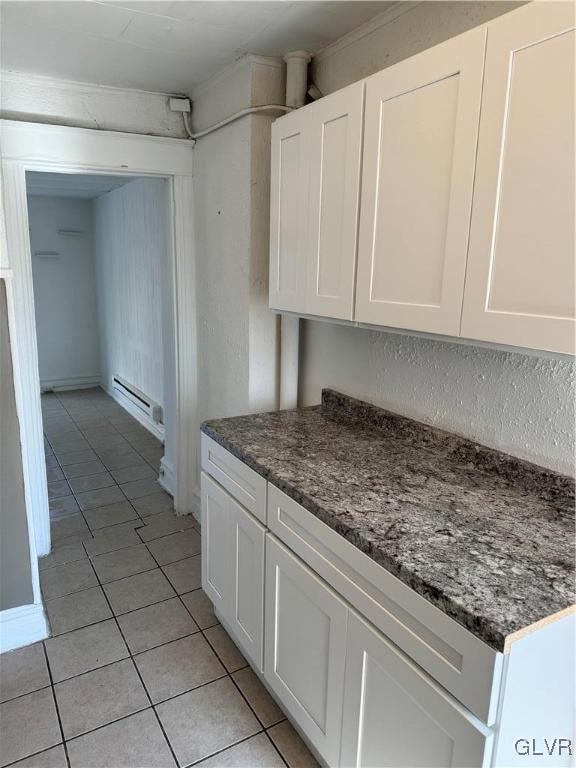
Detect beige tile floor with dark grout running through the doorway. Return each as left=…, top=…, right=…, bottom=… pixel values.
left=0, top=389, right=317, bottom=768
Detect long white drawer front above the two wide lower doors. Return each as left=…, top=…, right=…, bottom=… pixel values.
left=268, top=484, right=503, bottom=723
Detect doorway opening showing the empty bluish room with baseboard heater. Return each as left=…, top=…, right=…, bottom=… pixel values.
left=26, top=171, right=175, bottom=540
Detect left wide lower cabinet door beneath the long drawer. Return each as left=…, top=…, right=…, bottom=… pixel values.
left=264, top=534, right=348, bottom=766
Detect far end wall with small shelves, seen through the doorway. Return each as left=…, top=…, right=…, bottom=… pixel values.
left=28, top=196, right=100, bottom=387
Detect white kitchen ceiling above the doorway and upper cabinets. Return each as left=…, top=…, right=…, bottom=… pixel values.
left=0, top=0, right=396, bottom=93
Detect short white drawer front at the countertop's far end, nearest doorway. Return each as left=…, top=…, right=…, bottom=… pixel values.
left=202, top=434, right=266, bottom=523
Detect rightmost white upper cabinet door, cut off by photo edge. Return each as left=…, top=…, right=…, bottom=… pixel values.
left=461, top=3, right=576, bottom=352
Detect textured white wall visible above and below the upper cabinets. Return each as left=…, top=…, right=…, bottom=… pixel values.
left=300, top=2, right=574, bottom=472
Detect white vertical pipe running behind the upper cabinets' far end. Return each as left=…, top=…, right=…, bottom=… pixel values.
left=280, top=51, right=312, bottom=409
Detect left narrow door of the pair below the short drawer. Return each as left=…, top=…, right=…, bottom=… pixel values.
left=201, top=472, right=234, bottom=617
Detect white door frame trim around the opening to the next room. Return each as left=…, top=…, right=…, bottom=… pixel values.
left=0, top=120, right=199, bottom=559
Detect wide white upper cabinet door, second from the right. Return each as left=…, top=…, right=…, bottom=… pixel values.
left=356, top=28, right=486, bottom=336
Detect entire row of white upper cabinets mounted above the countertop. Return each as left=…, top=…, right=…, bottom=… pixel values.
left=270, top=2, right=576, bottom=354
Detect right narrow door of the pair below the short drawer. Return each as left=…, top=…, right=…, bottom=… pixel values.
left=228, top=499, right=266, bottom=671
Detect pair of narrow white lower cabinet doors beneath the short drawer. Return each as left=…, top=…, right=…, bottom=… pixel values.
left=202, top=473, right=266, bottom=671
